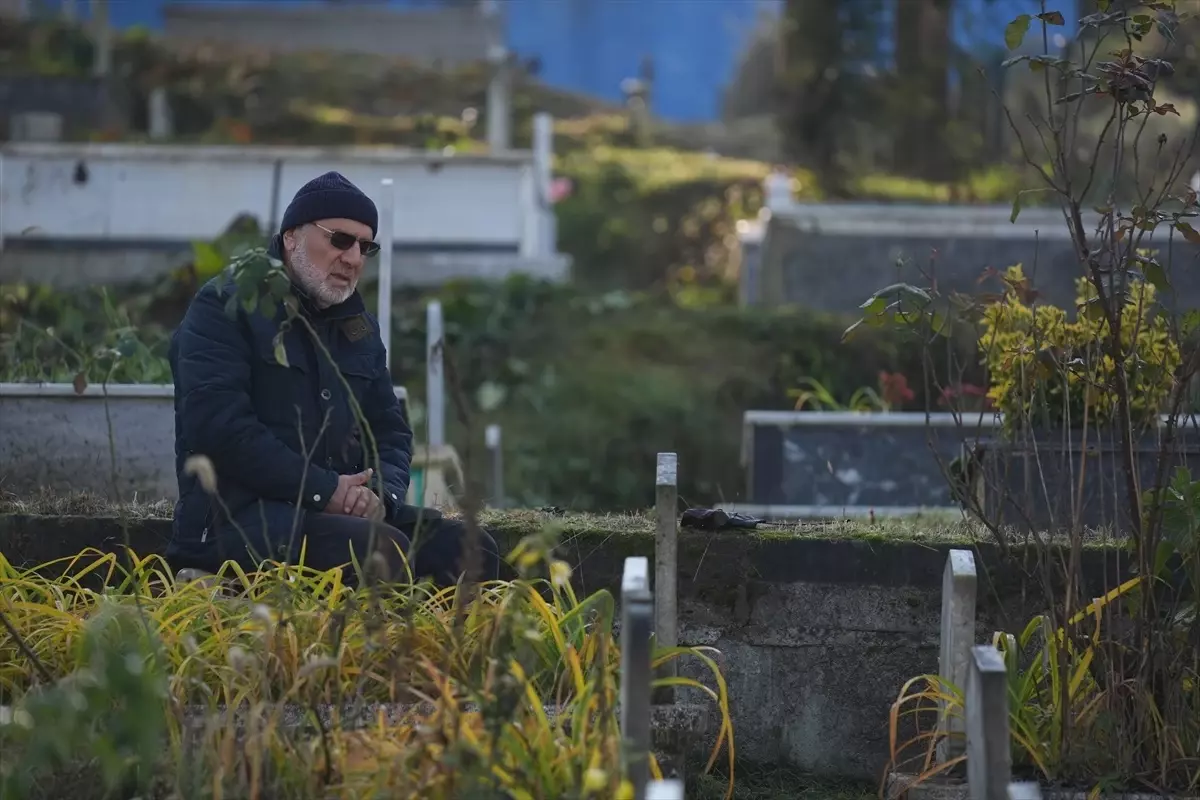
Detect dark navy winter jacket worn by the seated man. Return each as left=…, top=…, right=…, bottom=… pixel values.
left=168, top=276, right=413, bottom=569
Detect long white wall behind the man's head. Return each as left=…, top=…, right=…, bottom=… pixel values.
left=0, top=144, right=568, bottom=284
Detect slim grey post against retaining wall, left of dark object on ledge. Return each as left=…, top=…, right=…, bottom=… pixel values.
left=654, top=453, right=679, bottom=704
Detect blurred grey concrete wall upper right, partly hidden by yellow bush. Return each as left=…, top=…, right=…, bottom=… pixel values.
left=743, top=201, right=1200, bottom=313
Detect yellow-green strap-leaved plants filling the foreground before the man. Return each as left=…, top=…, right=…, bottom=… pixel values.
left=0, top=529, right=733, bottom=799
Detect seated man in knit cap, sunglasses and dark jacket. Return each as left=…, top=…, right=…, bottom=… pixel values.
left=167, top=172, right=499, bottom=585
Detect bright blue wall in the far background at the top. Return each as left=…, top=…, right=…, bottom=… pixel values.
left=46, top=0, right=1074, bottom=121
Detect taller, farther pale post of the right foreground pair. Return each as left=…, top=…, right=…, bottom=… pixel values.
left=937, top=549, right=978, bottom=764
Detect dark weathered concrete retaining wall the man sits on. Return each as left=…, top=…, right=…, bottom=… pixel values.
left=0, top=512, right=1120, bottom=780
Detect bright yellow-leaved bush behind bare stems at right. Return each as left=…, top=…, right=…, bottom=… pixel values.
left=979, top=265, right=1180, bottom=429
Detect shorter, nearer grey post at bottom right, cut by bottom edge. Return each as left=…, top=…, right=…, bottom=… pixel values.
left=966, top=644, right=1013, bottom=800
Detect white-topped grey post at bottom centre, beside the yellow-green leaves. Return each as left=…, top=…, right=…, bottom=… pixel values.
left=620, top=555, right=654, bottom=800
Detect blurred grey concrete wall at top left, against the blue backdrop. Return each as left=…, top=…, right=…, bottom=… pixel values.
left=162, top=2, right=504, bottom=66
